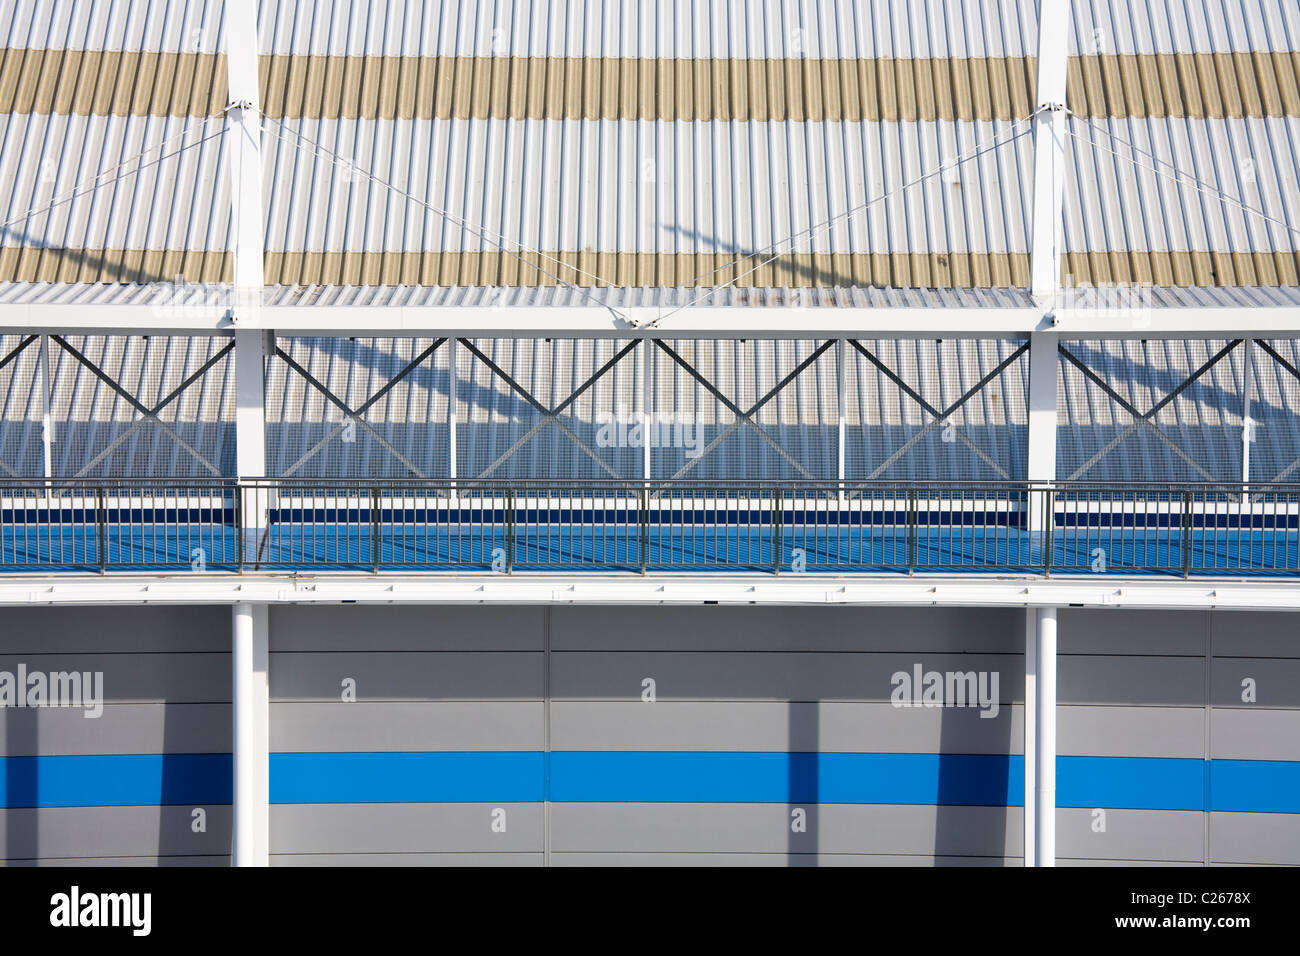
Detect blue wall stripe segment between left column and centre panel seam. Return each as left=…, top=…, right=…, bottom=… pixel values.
left=270, top=752, right=546, bottom=804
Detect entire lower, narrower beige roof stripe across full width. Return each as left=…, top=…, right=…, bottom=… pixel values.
left=0, top=246, right=1300, bottom=289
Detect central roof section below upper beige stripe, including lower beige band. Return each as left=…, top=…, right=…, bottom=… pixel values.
left=258, top=115, right=1032, bottom=286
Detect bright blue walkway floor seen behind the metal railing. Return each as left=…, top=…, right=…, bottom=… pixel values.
left=0, top=523, right=1300, bottom=576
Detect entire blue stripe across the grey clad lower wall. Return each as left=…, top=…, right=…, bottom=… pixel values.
left=0, top=752, right=1300, bottom=813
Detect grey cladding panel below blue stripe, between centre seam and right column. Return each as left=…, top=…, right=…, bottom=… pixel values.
left=551, top=804, right=1023, bottom=857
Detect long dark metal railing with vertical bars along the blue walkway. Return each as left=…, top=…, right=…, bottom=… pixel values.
left=0, top=479, right=1300, bottom=578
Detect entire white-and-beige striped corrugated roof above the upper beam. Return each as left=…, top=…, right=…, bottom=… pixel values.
left=0, top=0, right=1300, bottom=287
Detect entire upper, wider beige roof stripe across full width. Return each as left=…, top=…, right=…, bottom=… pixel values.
left=0, top=48, right=1300, bottom=122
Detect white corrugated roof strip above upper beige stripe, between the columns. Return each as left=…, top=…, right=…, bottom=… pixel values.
left=259, top=0, right=1037, bottom=59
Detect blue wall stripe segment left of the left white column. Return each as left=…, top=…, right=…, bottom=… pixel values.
left=0, top=753, right=231, bottom=809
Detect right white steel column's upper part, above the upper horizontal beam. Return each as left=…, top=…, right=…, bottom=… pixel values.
left=1030, top=0, right=1070, bottom=304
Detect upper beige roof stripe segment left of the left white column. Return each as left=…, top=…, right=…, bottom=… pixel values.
left=0, top=47, right=226, bottom=116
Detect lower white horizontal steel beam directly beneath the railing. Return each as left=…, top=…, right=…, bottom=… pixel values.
left=0, top=572, right=1300, bottom=611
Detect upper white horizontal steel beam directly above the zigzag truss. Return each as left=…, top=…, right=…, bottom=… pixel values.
left=0, top=303, right=1300, bottom=338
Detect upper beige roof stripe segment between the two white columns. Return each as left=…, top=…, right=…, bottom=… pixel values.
left=261, top=56, right=1034, bottom=121
